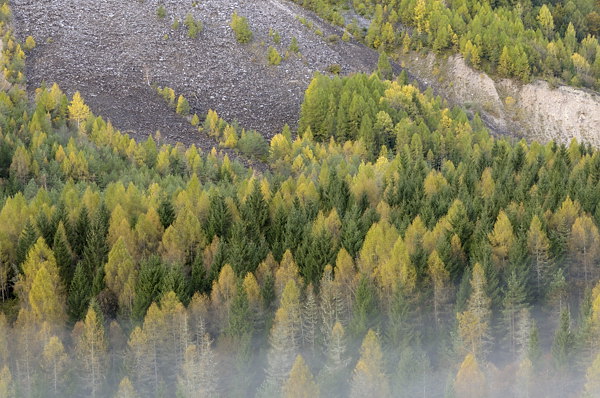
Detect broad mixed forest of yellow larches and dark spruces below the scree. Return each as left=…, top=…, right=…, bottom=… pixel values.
left=0, top=2, right=600, bottom=398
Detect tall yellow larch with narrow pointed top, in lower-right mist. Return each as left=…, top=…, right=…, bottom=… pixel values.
left=457, top=263, right=491, bottom=356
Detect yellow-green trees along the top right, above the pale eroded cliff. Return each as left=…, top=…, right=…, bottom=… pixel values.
left=297, top=0, right=600, bottom=89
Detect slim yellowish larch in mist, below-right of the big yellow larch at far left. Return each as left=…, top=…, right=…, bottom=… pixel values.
left=73, top=304, right=108, bottom=398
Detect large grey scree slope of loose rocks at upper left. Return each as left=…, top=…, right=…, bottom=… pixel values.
left=11, top=0, right=377, bottom=145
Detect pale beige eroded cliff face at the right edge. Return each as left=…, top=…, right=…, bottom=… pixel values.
left=400, top=53, right=600, bottom=146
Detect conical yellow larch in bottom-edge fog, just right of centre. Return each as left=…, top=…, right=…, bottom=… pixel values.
left=350, top=329, right=390, bottom=398
